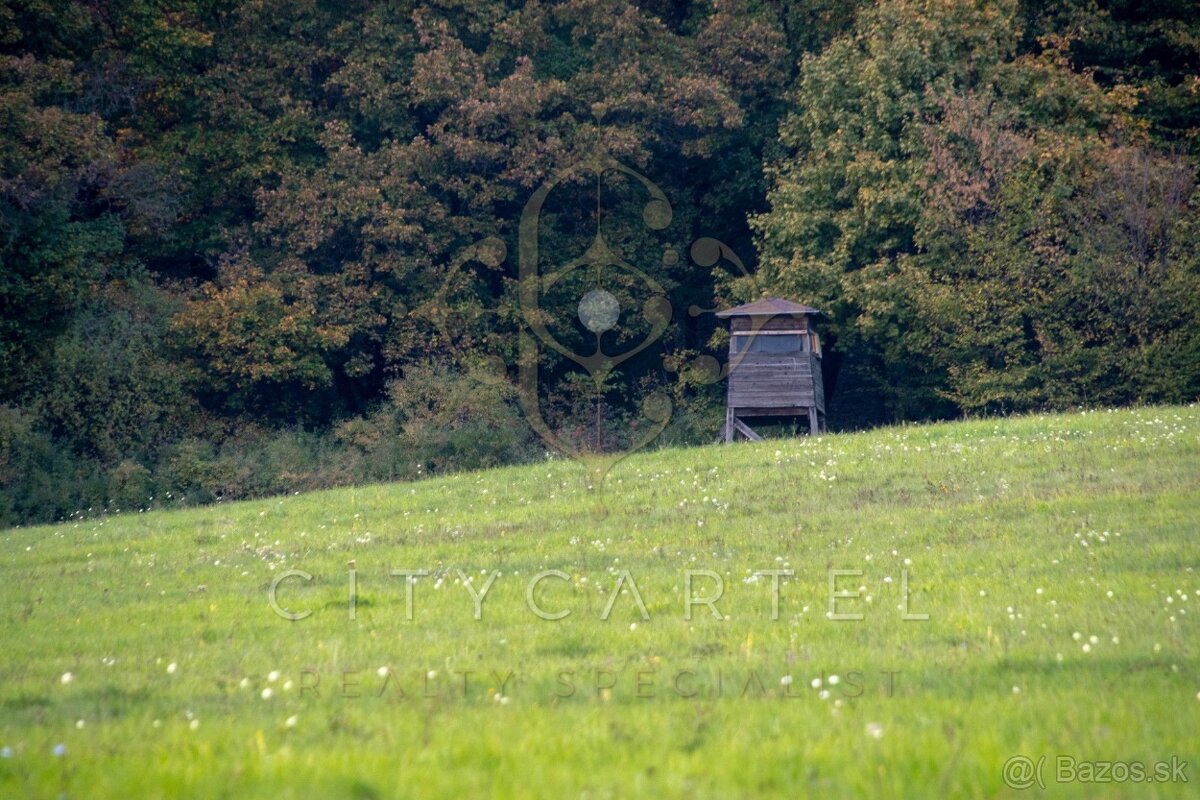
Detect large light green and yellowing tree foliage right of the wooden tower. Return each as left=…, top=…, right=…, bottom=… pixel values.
left=756, top=1, right=1200, bottom=419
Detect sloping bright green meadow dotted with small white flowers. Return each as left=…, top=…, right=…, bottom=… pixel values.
left=0, top=407, right=1200, bottom=799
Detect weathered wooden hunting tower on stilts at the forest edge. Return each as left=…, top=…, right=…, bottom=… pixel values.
left=716, top=297, right=824, bottom=441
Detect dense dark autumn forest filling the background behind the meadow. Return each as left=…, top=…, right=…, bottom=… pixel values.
left=0, top=0, right=1200, bottom=524
